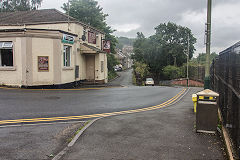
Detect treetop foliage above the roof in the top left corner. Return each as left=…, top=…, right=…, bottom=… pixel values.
left=0, top=0, right=42, bottom=12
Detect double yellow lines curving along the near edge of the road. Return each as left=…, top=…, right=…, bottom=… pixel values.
left=0, top=89, right=186, bottom=125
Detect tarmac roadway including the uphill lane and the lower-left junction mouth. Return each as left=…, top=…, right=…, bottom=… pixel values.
left=0, top=70, right=186, bottom=160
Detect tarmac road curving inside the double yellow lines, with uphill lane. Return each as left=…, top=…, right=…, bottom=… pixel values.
left=0, top=70, right=182, bottom=120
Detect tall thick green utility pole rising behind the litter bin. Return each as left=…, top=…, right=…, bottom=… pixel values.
left=204, top=0, right=212, bottom=89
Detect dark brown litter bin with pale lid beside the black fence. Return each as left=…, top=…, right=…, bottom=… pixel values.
left=196, top=89, right=219, bottom=133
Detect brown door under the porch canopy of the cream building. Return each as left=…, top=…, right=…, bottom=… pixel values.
left=86, top=55, right=95, bottom=81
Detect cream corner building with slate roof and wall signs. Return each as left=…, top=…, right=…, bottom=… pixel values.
left=0, top=9, right=108, bottom=87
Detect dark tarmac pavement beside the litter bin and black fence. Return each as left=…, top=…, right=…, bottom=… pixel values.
left=61, top=88, right=226, bottom=160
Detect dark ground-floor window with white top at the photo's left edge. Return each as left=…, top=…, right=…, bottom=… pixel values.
left=0, top=42, right=13, bottom=67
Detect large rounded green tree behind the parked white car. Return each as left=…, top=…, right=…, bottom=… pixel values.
left=132, top=22, right=196, bottom=80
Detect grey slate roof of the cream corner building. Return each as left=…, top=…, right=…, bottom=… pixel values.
left=0, top=9, right=78, bottom=25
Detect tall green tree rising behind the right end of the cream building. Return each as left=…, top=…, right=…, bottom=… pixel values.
left=62, top=0, right=117, bottom=53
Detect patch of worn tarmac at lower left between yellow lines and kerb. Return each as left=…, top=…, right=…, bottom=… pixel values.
left=0, top=122, right=86, bottom=160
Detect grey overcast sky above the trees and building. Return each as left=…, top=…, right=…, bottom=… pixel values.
left=41, top=0, right=240, bottom=53
